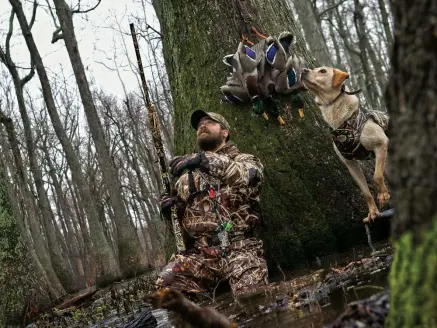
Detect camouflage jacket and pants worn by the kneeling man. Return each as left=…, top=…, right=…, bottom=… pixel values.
left=157, top=142, right=267, bottom=292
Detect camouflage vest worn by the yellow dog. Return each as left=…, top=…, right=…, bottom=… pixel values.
left=331, top=108, right=388, bottom=160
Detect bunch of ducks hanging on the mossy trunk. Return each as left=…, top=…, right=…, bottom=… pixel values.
left=220, top=29, right=306, bottom=124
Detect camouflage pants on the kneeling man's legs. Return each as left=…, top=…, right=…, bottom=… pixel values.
left=156, top=238, right=267, bottom=294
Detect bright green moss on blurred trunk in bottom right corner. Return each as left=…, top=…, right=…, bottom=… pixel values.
left=387, top=216, right=437, bottom=327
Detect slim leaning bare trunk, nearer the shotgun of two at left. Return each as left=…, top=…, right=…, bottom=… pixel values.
left=54, top=0, right=147, bottom=275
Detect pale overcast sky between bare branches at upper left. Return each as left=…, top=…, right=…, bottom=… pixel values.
left=0, top=0, right=159, bottom=102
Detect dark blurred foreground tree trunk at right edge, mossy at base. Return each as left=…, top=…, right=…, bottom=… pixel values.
left=387, top=0, right=437, bottom=327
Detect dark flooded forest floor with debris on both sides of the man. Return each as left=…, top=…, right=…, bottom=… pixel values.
left=26, top=240, right=393, bottom=328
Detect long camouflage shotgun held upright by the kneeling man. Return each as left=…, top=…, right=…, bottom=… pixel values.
left=130, top=23, right=186, bottom=253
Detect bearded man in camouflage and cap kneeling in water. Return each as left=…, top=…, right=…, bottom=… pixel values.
left=157, top=110, right=267, bottom=295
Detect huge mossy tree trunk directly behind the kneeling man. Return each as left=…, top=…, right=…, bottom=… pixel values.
left=154, top=0, right=382, bottom=269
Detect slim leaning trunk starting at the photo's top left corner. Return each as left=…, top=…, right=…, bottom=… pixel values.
left=9, top=0, right=120, bottom=280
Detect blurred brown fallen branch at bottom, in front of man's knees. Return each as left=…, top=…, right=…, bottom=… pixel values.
left=149, top=289, right=238, bottom=328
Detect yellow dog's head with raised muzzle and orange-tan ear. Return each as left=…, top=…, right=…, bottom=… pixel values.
left=300, top=66, right=349, bottom=98
